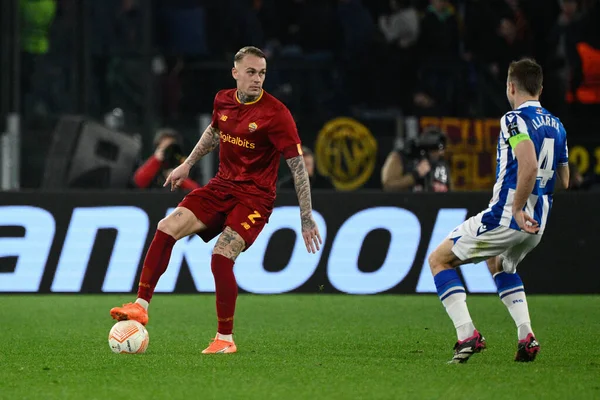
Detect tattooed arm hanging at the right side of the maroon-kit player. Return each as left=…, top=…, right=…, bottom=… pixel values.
left=286, top=156, right=323, bottom=253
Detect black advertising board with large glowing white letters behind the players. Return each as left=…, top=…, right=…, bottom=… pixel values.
left=0, top=192, right=600, bottom=294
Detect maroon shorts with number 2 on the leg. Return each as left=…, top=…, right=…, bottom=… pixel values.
left=179, top=183, right=273, bottom=250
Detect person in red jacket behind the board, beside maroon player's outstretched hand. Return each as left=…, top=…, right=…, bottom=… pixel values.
left=133, top=129, right=200, bottom=190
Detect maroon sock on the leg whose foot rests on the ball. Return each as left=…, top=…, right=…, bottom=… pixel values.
left=138, top=230, right=176, bottom=302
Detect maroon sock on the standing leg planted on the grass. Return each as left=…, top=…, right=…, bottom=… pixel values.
left=211, top=254, right=237, bottom=335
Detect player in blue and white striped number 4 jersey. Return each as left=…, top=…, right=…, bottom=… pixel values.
left=429, top=59, right=569, bottom=363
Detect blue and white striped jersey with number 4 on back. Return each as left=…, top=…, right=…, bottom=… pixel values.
left=482, top=101, right=569, bottom=234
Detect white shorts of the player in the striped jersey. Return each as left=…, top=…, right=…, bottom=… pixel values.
left=448, top=212, right=542, bottom=274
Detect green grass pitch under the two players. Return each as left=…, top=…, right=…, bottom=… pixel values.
left=0, top=294, right=600, bottom=400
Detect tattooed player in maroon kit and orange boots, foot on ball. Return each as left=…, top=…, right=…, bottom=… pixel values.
left=110, top=47, right=322, bottom=354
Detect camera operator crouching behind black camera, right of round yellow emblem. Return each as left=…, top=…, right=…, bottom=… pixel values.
left=381, top=130, right=450, bottom=192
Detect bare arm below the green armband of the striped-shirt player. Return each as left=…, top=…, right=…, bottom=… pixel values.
left=512, top=140, right=540, bottom=233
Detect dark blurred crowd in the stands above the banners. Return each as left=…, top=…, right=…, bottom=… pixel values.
left=21, top=0, right=600, bottom=120
